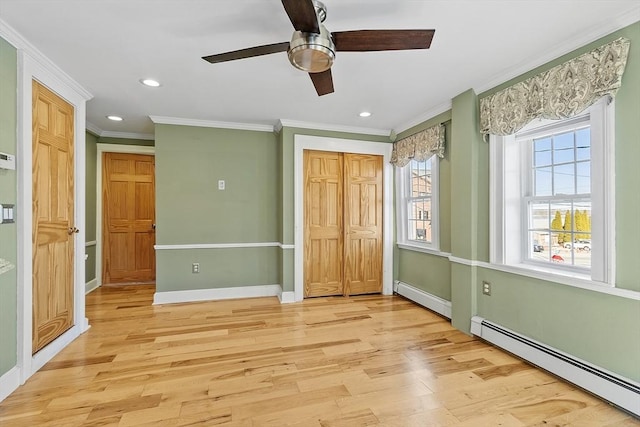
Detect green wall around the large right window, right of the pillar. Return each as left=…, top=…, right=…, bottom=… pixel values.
left=476, top=22, right=640, bottom=381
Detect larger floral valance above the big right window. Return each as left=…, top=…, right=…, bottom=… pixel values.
left=480, top=38, right=630, bottom=135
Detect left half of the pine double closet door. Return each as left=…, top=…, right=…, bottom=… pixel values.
left=304, top=151, right=344, bottom=297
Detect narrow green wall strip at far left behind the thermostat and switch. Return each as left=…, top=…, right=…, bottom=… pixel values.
left=0, top=38, right=17, bottom=376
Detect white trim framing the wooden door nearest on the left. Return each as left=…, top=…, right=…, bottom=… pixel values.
left=17, top=49, right=91, bottom=382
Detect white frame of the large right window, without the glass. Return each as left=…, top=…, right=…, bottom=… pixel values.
left=489, top=98, right=615, bottom=286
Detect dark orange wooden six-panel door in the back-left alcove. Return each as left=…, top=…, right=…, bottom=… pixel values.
left=102, top=153, right=156, bottom=284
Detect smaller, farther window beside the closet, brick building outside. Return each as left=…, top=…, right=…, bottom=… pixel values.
left=397, top=155, right=438, bottom=249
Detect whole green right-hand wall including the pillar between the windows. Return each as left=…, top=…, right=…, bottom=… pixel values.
left=398, top=23, right=640, bottom=381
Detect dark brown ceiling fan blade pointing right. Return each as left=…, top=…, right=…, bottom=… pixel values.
left=331, top=30, right=436, bottom=52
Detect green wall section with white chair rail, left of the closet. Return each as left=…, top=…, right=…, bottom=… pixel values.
left=155, top=125, right=280, bottom=292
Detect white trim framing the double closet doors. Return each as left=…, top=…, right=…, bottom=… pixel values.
left=293, top=135, right=394, bottom=301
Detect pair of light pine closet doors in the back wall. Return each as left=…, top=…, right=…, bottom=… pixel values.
left=304, top=150, right=383, bottom=297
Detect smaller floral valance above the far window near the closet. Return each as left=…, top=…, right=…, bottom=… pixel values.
left=391, top=124, right=444, bottom=167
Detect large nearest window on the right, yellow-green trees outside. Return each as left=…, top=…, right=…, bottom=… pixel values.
left=490, top=100, right=614, bottom=283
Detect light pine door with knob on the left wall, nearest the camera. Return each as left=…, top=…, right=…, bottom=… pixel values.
left=32, top=81, right=77, bottom=354
